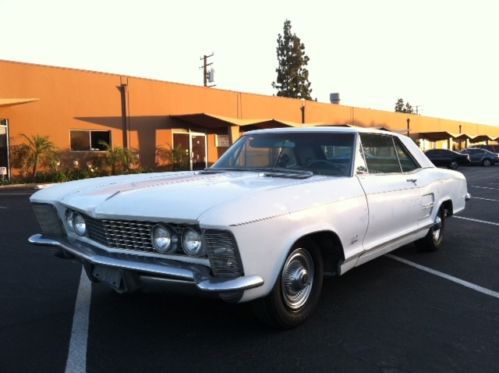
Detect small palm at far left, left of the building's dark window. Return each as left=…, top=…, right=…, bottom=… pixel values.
left=13, top=134, right=57, bottom=180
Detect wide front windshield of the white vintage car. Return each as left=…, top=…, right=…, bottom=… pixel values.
left=208, top=132, right=354, bottom=176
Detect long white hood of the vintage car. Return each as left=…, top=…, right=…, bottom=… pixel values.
left=31, top=172, right=323, bottom=223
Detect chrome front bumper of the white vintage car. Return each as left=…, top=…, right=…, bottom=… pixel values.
left=28, top=234, right=263, bottom=293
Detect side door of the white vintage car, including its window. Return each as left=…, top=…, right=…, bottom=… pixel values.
left=357, top=133, right=421, bottom=251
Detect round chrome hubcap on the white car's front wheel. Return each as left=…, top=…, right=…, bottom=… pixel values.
left=281, top=249, right=314, bottom=310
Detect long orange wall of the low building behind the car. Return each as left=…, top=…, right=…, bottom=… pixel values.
left=0, top=60, right=499, bottom=167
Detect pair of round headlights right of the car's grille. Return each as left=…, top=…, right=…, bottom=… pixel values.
left=151, top=224, right=206, bottom=256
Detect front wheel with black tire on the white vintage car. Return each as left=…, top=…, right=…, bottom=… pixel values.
left=253, top=241, right=323, bottom=329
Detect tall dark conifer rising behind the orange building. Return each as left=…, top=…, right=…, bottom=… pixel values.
left=272, top=20, right=312, bottom=100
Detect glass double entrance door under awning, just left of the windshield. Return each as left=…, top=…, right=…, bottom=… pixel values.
left=173, top=131, right=207, bottom=170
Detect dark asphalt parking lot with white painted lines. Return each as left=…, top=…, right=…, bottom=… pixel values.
left=0, top=166, right=499, bottom=372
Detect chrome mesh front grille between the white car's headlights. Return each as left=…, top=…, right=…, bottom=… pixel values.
left=85, top=216, right=155, bottom=251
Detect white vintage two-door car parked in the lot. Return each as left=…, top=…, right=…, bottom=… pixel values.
left=29, top=127, right=469, bottom=328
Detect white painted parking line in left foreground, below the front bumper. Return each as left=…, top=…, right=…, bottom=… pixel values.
left=65, top=268, right=92, bottom=373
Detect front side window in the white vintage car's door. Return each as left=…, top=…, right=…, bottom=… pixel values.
left=360, top=133, right=401, bottom=174
